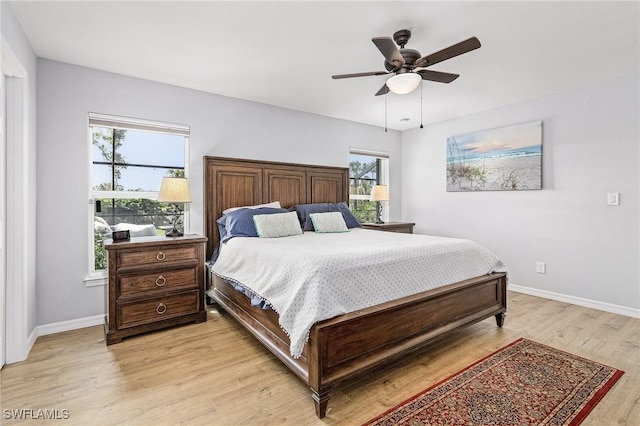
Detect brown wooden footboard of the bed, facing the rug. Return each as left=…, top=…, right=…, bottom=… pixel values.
left=308, top=274, right=506, bottom=417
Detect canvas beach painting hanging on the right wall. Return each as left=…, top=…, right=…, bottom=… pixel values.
left=447, top=121, right=542, bottom=192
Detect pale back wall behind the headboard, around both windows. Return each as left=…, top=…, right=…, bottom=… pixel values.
left=37, top=59, right=400, bottom=325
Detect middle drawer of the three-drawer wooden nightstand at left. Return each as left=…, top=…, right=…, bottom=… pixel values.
left=120, top=267, right=198, bottom=296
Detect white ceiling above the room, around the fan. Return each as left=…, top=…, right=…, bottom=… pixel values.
left=10, top=1, right=640, bottom=130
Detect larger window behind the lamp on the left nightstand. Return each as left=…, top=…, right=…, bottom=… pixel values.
left=89, top=114, right=189, bottom=273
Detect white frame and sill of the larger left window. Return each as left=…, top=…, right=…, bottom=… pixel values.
left=84, top=112, right=191, bottom=287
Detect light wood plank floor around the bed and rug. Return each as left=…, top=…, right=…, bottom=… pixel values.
left=0, top=292, right=640, bottom=426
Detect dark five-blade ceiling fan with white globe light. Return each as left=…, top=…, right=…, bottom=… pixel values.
left=331, top=30, right=481, bottom=96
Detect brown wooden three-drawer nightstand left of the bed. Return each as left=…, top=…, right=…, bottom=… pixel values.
left=105, top=235, right=207, bottom=345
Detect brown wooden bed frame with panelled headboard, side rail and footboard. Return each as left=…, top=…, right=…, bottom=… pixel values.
left=204, top=157, right=507, bottom=418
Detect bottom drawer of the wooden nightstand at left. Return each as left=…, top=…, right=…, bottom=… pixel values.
left=118, top=291, right=199, bottom=328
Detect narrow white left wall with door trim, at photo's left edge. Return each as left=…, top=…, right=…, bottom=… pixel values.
left=0, top=2, right=37, bottom=363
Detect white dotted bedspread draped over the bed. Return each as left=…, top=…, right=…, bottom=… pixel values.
left=212, top=228, right=506, bottom=357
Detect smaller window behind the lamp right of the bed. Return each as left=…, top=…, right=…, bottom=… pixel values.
left=349, top=149, right=389, bottom=223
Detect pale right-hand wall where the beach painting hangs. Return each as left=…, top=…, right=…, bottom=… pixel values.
left=401, top=75, right=640, bottom=315
